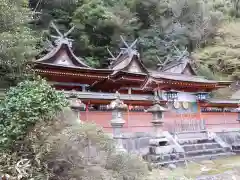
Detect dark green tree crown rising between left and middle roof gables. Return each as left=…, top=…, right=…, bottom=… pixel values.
left=72, top=0, right=136, bottom=65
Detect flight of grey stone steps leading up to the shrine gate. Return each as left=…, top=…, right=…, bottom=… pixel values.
left=176, top=131, right=233, bottom=161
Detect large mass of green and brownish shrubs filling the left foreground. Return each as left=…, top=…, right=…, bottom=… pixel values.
left=0, top=79, right=148, bottom=180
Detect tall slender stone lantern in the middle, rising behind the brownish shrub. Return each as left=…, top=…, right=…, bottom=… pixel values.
left=110, top=92, right=127, bottom=151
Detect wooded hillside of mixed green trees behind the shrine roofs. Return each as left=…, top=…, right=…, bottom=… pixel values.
left=0, top=0, right=240, bottom=86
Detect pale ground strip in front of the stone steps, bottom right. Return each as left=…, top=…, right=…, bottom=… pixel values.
left=147, top=156, right=240, bottom=180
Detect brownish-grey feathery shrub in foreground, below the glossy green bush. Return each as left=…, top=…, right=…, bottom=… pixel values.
left=0, top=108, right=148, bottom=180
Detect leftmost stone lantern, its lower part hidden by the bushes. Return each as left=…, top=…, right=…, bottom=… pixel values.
left=68, top=93, right=85, bottom=119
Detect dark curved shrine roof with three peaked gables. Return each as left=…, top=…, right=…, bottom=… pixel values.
left=34, top=35, right=231, bottom=89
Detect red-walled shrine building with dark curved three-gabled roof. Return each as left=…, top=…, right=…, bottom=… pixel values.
left=33, top=28, right=240, bottom=132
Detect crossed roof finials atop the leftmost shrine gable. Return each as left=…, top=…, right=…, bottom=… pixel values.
left=50, top=22, right=75, bottom=47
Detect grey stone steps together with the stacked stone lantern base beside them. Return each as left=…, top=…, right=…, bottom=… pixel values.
left=145, top=131, right=235, bottom=167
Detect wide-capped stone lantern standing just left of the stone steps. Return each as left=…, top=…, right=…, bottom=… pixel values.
left=147, top=100, right=167, bottom=137
